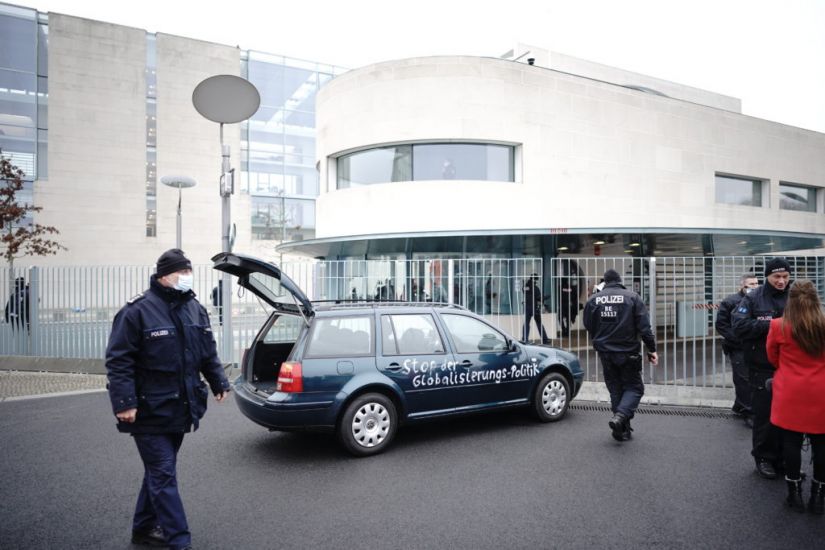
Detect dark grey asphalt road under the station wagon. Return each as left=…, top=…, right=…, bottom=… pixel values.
left=0, top=393, right=825, bottom=550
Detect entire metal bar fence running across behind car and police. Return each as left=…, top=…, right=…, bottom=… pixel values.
left=0, top=256, right=825, bottom=387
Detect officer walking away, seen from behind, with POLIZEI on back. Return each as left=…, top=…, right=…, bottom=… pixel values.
left=584, top=269, right=659, bottom=441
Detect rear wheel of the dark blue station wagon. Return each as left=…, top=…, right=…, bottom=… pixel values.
left=338, top=393, right=398, bottom=456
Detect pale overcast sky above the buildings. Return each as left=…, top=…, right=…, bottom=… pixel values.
left=11, top=0, right=825, bottom=132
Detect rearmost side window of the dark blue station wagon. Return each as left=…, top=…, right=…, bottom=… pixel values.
left=306, top=317, right=373, bottom=357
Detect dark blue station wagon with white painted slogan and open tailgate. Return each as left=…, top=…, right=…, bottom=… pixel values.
left=212, top=253, right=584, bottom=456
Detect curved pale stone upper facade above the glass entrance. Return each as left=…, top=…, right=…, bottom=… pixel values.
left=317, top=56, right=825, bottom=244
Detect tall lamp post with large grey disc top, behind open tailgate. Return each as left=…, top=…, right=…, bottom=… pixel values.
left=192, top=74, right=261, bottom=363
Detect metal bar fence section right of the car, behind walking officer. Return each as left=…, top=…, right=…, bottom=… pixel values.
left=545, top=256, right=825, bottom=387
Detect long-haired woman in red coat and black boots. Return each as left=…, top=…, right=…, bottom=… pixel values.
left=767, top=281, right=825, bottom=515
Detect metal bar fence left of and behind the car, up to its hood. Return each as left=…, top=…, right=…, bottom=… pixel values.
left=0, top=258, right=541, bottom=363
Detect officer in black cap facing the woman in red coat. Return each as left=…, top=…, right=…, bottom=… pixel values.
left=733, top=258, right=791, bottom=479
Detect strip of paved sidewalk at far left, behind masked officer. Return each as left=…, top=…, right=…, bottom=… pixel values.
left=0, top=370, right=106, bottom=401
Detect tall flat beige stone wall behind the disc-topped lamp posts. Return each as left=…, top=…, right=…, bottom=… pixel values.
left=30, top=13, right=249, bottom=265
